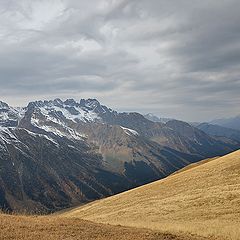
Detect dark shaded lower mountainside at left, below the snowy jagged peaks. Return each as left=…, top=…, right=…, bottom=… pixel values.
left=0, top=128, right=134, bottom=212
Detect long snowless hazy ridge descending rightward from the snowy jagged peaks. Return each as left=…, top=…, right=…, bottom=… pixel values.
left=97, top=106, right=239, bottom=159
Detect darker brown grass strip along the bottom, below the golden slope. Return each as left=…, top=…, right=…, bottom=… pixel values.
left=0, top=214, right=205, bottom=240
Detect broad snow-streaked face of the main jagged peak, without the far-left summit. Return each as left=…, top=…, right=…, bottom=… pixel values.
left=26, top=99, right=101, bottom=140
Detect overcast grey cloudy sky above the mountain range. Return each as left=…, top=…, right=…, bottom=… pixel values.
left=0, top=0, right=240, bottom=121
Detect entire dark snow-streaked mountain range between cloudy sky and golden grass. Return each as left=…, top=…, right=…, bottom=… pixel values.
left=0, top=99, right=239, bottom=212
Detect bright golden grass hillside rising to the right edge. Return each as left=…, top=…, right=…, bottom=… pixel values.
left=64, top=150, right=240, bottom=240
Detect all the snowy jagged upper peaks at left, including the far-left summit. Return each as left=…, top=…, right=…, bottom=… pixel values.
left=0, top=98, right=116, bottom=139
